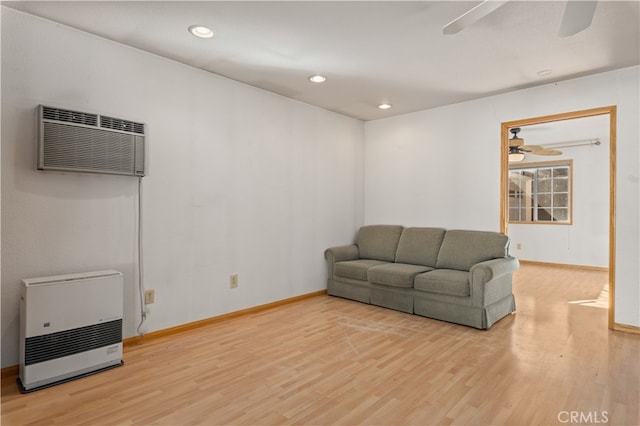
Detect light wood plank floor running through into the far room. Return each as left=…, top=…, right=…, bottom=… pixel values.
left=1, top=265, right=640, bottom=425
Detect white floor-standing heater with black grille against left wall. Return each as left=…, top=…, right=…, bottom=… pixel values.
left=18, top=270, right=123, bottom=393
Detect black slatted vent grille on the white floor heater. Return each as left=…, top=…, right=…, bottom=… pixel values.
left=24, top=319, right=122, bottom=365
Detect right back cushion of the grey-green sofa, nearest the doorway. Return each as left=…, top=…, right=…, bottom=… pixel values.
left=436, top=230, right=509, bottom=271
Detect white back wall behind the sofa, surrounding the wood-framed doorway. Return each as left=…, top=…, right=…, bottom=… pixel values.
left=365, top=67, right=640, bottom=326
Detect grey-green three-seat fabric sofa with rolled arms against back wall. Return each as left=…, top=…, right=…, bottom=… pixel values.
left=325, top=225, right=519, bottom=329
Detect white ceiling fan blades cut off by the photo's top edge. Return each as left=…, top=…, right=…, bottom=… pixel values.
left=442, top=0, right=597, bottom=37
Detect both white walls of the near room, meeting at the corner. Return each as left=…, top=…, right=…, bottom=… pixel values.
left=5, top=7, right=640, bottom=372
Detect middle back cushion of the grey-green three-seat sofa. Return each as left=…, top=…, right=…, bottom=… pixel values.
left=396, top=228, right=445, bottom=267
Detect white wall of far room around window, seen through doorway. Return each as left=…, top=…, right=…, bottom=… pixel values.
left=508, top=114, right=610, bottom=268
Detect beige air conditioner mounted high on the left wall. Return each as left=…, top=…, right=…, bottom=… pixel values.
left=37, top=105, right=145, bottom=176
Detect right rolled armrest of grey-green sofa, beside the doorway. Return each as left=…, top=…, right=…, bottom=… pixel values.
left=469, top=256, right=520, bottom=306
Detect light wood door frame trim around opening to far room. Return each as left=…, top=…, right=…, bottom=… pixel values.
left=500, top=106, right=616, bottom=329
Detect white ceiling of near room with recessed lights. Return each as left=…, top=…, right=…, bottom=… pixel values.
left=2, top=0, right=640, bottom=120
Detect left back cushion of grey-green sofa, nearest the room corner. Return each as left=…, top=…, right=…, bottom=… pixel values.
left=356, top=225, right=403, bottom=262
